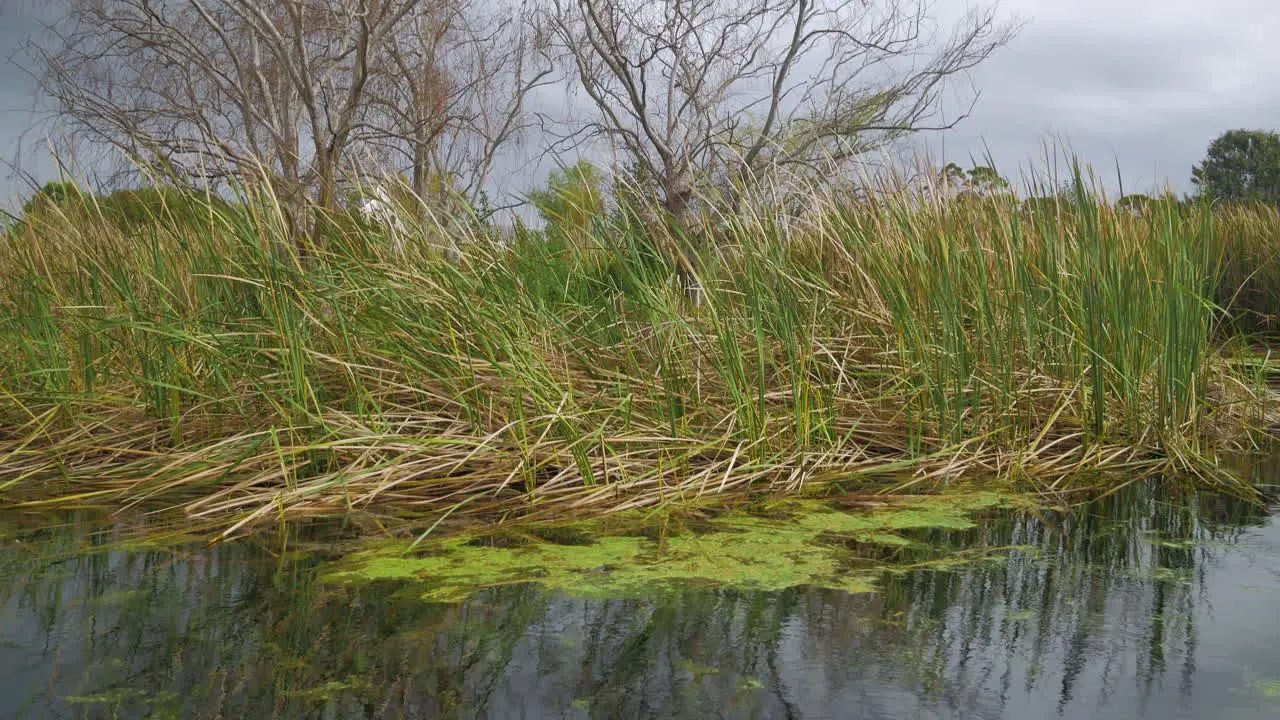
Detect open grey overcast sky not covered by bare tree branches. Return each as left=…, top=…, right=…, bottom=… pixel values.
left=0, top=0, right=1280, bottom=208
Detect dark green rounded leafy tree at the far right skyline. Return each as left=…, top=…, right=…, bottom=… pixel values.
left=1192, top=129, right=1280, bottom=204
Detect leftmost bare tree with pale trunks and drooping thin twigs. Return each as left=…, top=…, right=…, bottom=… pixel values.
left=37, top=0, right=435, bottom=208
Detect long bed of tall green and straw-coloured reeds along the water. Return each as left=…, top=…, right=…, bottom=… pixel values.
left=0, top=178, right=1280, bottom=534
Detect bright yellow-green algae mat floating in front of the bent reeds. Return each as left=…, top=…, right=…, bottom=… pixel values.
left=328, top=493, right=1010, bottom=602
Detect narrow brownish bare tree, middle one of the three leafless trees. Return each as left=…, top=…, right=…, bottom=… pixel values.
left=369, top=0, right=553, bottom=212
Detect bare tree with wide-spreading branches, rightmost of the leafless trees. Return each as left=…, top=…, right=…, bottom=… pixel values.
left=541, top=0, right=1016, bottom=223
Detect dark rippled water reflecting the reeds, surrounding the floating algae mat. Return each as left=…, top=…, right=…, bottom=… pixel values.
left=0, top=487, right=1280, bottom=720
